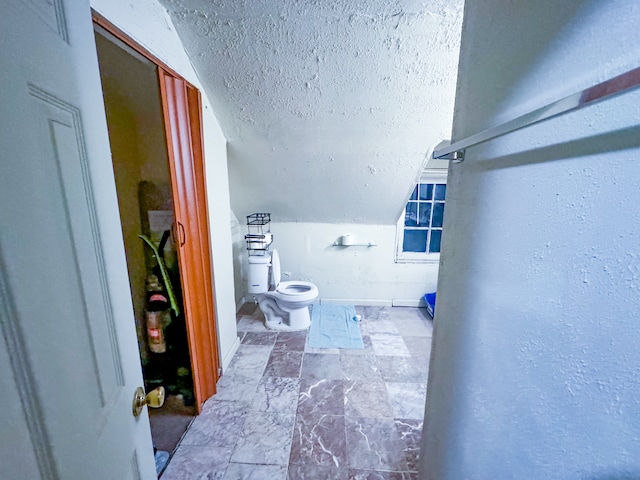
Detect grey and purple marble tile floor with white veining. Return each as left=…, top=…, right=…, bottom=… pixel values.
left=161, top=304, right=433, bottom=480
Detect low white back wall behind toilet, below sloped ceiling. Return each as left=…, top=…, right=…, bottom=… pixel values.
left=244, top=222, right=438, bottom=306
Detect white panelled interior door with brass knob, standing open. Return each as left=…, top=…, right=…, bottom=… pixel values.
left=0, top=0, right=155, bottom=479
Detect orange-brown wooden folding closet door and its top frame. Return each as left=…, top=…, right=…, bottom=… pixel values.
left=91, top=13, right=221, bottom=413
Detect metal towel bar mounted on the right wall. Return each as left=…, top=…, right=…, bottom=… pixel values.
left=433, top=67, right=640, bottom=163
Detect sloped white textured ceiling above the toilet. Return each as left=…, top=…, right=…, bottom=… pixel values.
left=160, top=0, right=463, bottom=224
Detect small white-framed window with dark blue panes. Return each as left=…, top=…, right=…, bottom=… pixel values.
left=396, top=171, right=447, bottom=262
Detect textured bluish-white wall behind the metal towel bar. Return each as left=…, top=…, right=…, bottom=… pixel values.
left=421, top=0, right=640, bottom=480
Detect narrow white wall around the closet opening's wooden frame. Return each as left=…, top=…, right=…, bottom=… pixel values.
left=91, top=0, right=238, bottom=368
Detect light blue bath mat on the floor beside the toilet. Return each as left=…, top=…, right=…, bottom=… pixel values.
left=309, top=305, right=364, bottom=348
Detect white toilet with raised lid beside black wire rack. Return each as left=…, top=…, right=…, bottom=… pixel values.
left=249, top=250, right=318, bottom=331
